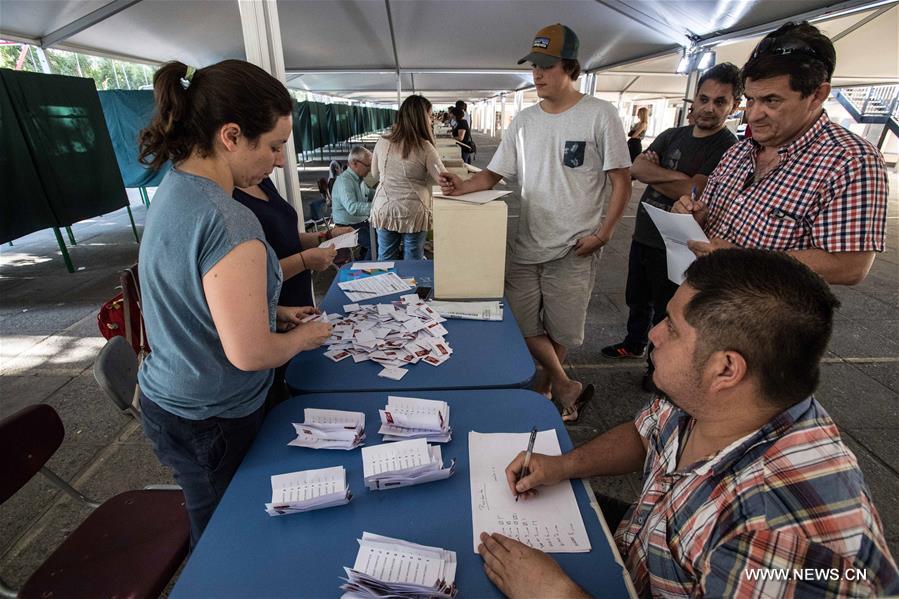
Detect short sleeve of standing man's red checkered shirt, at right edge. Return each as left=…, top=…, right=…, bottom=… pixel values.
left=811, top=153, right=887, bottom=252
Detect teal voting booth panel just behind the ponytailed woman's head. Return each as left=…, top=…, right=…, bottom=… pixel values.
left=98, top=89, right=171, bottom=187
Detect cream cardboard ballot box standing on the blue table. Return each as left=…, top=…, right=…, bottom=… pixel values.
left=434, top=198, right=508, bottom=299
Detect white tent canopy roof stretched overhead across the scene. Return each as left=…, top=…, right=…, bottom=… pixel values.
left=0, top=0, right=899, bottom=103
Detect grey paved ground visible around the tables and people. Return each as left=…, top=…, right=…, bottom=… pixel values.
left=0, top=137, right=899, bottom=585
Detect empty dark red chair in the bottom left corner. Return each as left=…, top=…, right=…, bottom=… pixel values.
left=0, top=404, right=190, bottom=599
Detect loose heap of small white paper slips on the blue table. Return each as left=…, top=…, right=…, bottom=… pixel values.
left=323, top=294, right=453, bottom=372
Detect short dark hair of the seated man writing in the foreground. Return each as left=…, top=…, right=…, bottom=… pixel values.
left=684, top=249, right=840, bottom=409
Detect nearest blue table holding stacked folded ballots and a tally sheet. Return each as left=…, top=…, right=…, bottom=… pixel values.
left=171, top=389, right=632, bottom=599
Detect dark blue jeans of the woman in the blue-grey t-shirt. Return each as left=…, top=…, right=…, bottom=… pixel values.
left=140, top=394, right=263, bottom=549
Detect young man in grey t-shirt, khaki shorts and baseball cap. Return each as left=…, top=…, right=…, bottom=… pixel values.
left=440, top=23, right=631, bottom=422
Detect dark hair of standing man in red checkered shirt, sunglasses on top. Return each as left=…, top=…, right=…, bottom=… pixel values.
left=740, top=22, right=837, bottom=98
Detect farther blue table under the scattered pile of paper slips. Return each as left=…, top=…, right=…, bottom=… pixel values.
left=285, top=260, right=535, bottom=393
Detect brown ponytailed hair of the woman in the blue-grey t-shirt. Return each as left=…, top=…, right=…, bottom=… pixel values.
left=138, top=60, right=293, bottom=170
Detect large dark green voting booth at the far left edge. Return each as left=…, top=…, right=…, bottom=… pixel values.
left=0, top=69, right=128, bottom=242
